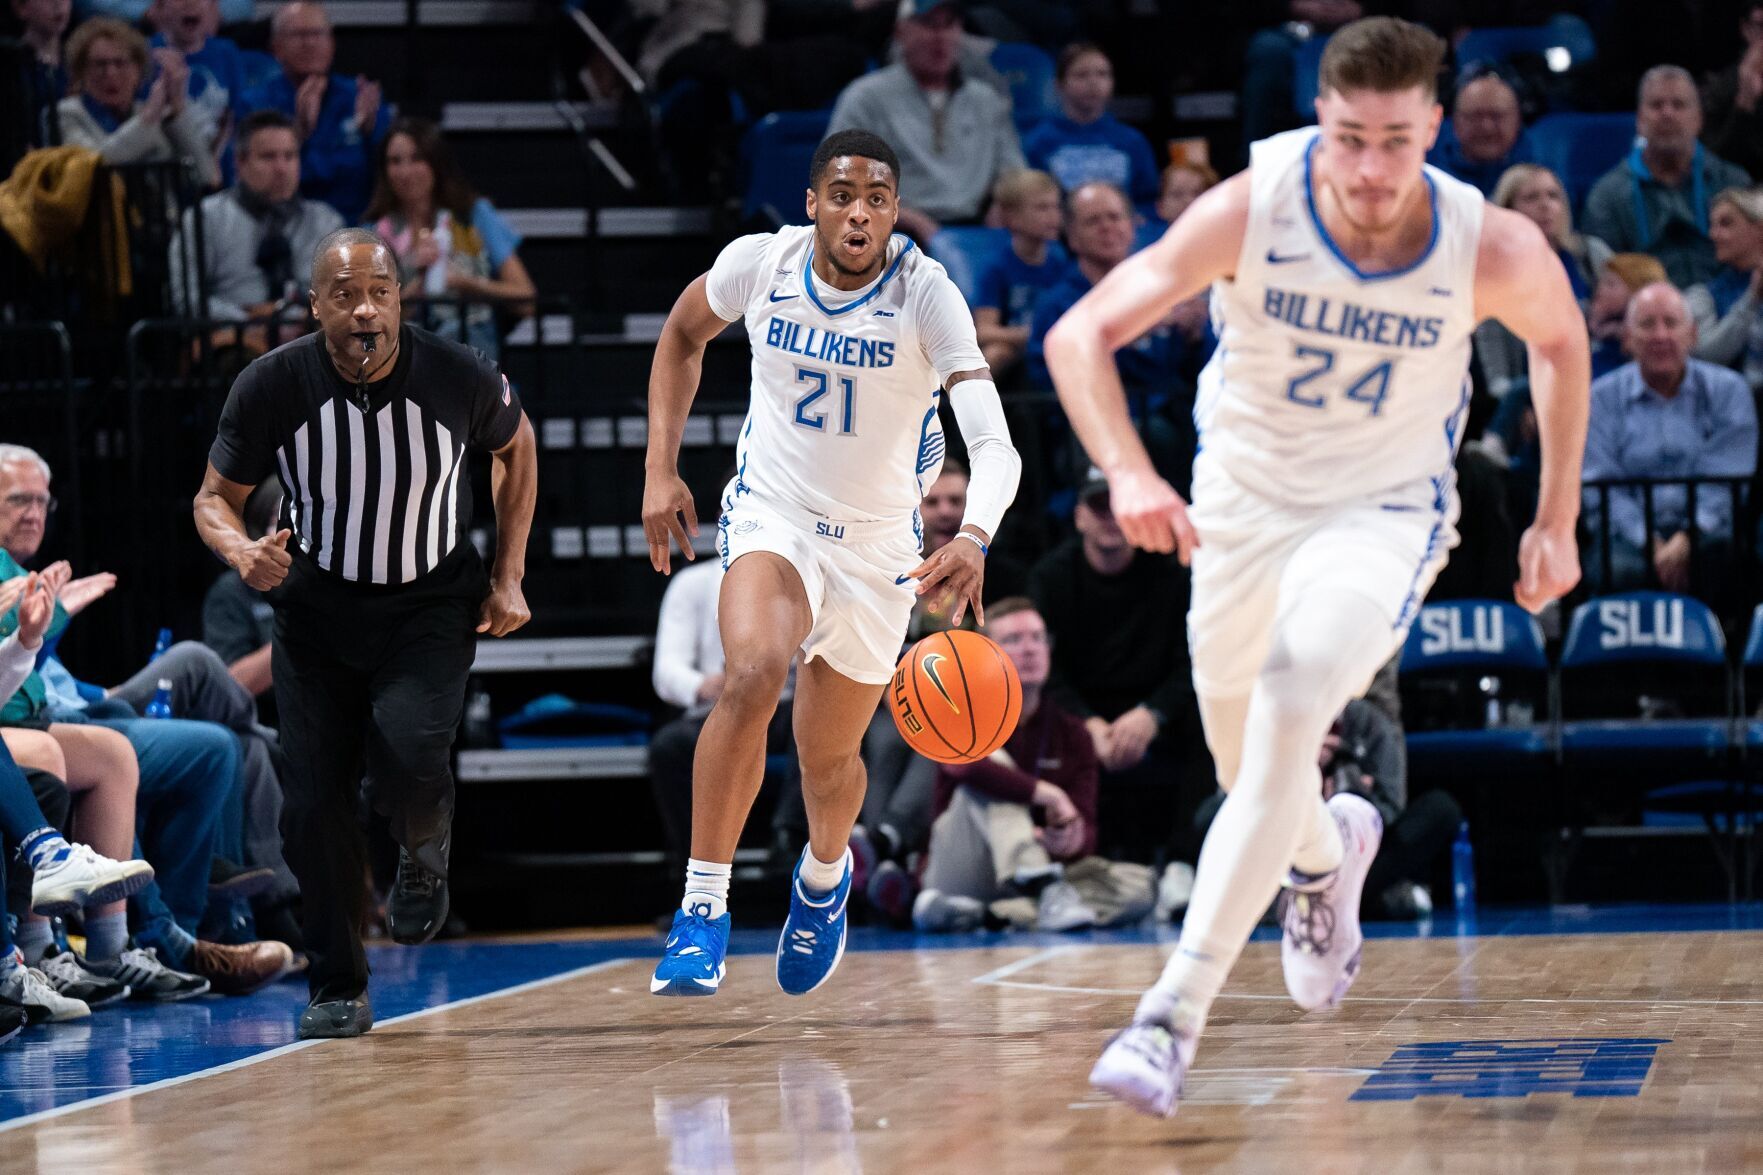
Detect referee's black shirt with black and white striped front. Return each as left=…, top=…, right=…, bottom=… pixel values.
left=208, top=325, right=520, bottom=584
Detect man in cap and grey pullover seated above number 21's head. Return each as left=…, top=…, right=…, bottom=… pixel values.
left=827, top=0, right=1024, bottom=243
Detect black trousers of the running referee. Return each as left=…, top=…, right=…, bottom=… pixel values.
left=270, top=543, right=488, bottom=1000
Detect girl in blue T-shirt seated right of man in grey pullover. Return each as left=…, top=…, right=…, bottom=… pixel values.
left=1023, top=44, right=1157, bottom=208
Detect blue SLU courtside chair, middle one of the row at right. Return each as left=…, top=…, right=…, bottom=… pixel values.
left=1555, top=591, right=1738, bottom=898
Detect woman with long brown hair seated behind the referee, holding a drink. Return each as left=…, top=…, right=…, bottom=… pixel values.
left=367, top=118, right=536, bottom=360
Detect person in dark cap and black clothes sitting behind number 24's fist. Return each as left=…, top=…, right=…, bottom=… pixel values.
left=1028, top=469, right=1215, bottom=859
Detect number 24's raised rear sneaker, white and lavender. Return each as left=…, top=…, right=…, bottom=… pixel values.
left=1280, top=792, right=1384, bottom=1011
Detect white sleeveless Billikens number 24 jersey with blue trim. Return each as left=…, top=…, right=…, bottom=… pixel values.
left=1194, top=127, right=1483, bottom=512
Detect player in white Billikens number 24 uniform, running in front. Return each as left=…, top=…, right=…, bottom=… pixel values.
left=1047, top=18, right=1590, bottom=1115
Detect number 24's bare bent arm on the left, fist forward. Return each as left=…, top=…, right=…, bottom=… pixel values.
left=1045, top=171, right=1248, bottom=563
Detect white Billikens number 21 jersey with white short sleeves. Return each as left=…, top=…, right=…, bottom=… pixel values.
left=705, top=226, right=986, bottom=533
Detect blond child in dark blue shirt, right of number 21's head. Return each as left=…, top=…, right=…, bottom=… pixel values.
left=973, top=169, right=1070, bottom=376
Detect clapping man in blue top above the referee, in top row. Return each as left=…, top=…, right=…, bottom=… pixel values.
left=245, top=0, right=391, bottom=224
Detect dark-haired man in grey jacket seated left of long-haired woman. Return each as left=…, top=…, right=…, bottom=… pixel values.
left=171, top=109, right=342, bottom=321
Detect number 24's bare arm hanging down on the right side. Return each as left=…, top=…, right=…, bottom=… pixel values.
left=1476, top=205, right=1592, bottom=612
